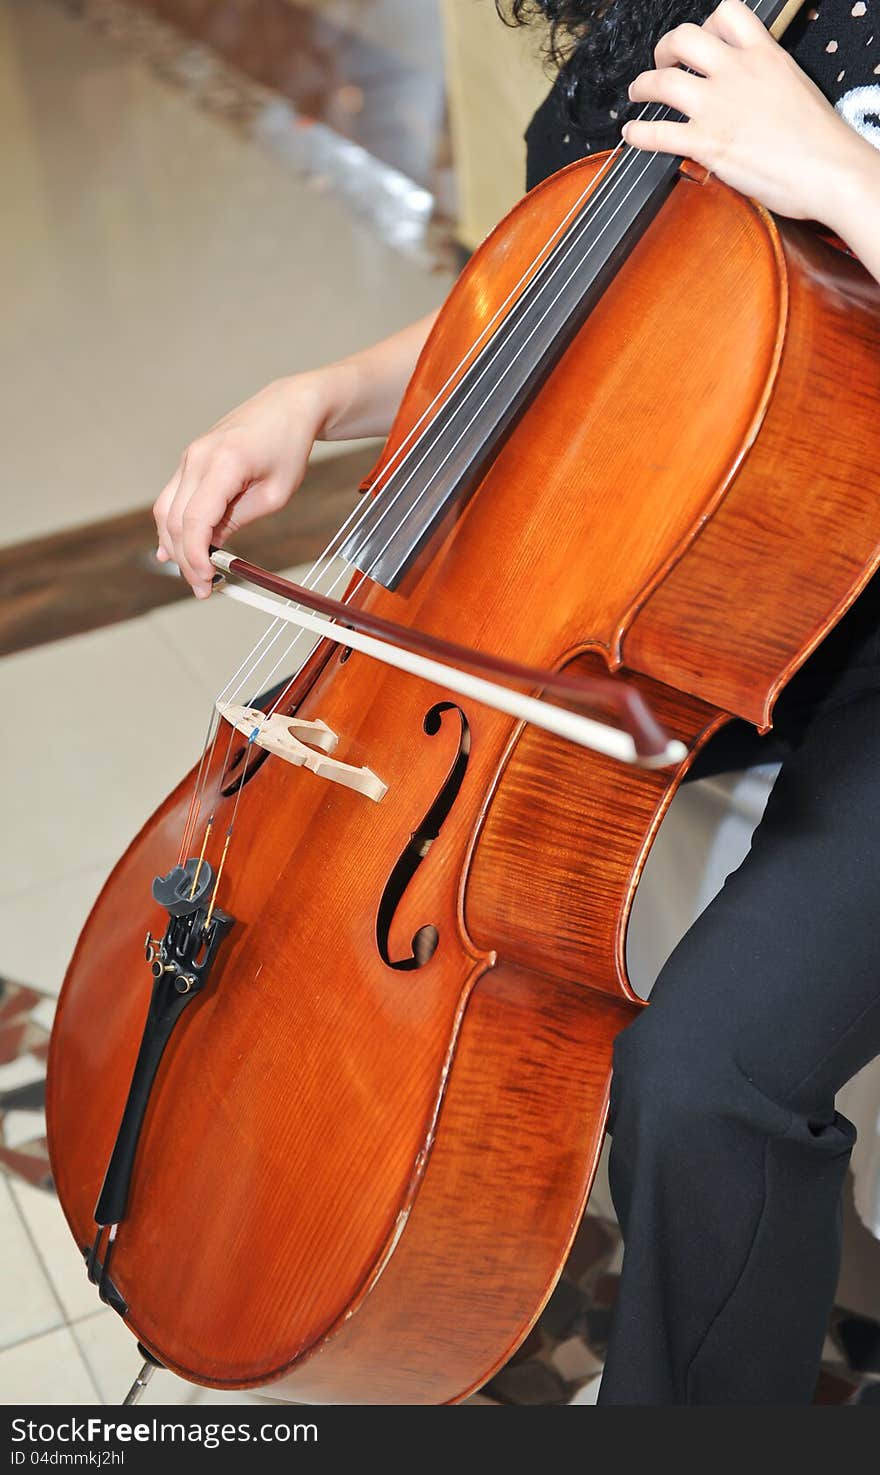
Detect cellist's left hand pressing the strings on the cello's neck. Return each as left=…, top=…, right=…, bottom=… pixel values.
left=624, top=0, right=870, bottom=226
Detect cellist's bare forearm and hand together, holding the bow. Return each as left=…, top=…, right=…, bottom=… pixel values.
left=153, top=313, right=436, bottom=599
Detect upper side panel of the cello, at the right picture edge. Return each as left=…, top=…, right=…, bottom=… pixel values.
left=622, top=207, right=880, bottom=729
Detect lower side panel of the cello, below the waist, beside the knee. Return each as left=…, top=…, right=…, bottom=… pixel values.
left=274, top=966, right=641, bottom=1403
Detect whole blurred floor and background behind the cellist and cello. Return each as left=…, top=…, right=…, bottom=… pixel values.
left=0, top=0, right=880, bottom=1404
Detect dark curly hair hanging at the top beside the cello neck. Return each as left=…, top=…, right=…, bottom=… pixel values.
left=495, top=0, right=718, bottom=125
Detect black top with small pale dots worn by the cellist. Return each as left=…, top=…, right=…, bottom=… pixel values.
left=526, top=0, right=880, bottom=189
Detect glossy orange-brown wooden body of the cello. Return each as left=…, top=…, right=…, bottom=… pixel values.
left=47, top=159, right=880, bottom=1404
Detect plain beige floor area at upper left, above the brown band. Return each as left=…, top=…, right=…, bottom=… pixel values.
left=0, top=0, right=445, bottom=543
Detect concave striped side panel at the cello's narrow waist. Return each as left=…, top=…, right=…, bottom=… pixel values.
left=466, top=655, right=719, bottom=996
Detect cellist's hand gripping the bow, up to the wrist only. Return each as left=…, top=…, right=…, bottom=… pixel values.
left=153, top=373, right=332, bottom=599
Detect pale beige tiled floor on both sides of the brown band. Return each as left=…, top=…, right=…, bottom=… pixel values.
left=0, top=0, right=868, bottom=1404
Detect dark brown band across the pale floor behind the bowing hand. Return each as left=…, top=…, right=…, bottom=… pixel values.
left=0, top=448, right=374, bottom=656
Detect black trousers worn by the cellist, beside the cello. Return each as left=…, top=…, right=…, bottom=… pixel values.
left=600, top=580, right=880, bottom=1404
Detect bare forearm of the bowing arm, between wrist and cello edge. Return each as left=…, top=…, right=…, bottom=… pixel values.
left=305, top=313, right=436, bottom=441
